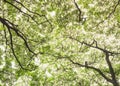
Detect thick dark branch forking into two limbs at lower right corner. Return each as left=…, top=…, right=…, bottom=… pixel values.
left=69, top=37, right=120, bottom=86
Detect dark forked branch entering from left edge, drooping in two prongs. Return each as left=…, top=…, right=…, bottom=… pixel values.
left=0, top=17, right=36, bottom=70
